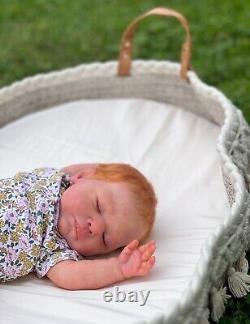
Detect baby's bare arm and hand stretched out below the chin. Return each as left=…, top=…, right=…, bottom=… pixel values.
left=47, top=240, right=155, bottom=290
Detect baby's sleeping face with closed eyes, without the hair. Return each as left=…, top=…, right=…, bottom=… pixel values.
left=58, top=171, right=145, bottom=256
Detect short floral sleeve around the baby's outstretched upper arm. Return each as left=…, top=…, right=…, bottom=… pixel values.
left=35, top=248, right=79, bottom=278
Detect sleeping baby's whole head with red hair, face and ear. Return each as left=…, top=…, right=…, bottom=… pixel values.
left=58, top=163, right=157, bottom=256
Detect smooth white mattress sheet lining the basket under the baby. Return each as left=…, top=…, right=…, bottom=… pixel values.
left=0, top=99, right=229, bottom=324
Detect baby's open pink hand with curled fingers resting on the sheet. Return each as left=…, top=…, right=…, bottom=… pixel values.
left=118, top=240, right=156, bottom=279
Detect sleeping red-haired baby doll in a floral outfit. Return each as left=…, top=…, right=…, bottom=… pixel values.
left=0, top=164, right=157, bottom=290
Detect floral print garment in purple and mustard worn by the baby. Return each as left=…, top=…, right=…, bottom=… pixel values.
left=0, top=168, right=80, bottom=282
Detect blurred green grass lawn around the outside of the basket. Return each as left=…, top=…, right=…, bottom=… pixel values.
left=0, top=0, right=250, bottom=324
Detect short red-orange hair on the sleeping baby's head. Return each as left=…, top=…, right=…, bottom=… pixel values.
left=93, top=163, right=157, bottom=243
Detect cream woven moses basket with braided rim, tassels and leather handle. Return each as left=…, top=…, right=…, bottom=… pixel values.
left=0, top=8, right=250, bottom=324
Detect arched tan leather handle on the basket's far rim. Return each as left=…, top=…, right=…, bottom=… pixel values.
left=117, top=7, right=191, bottom=81
